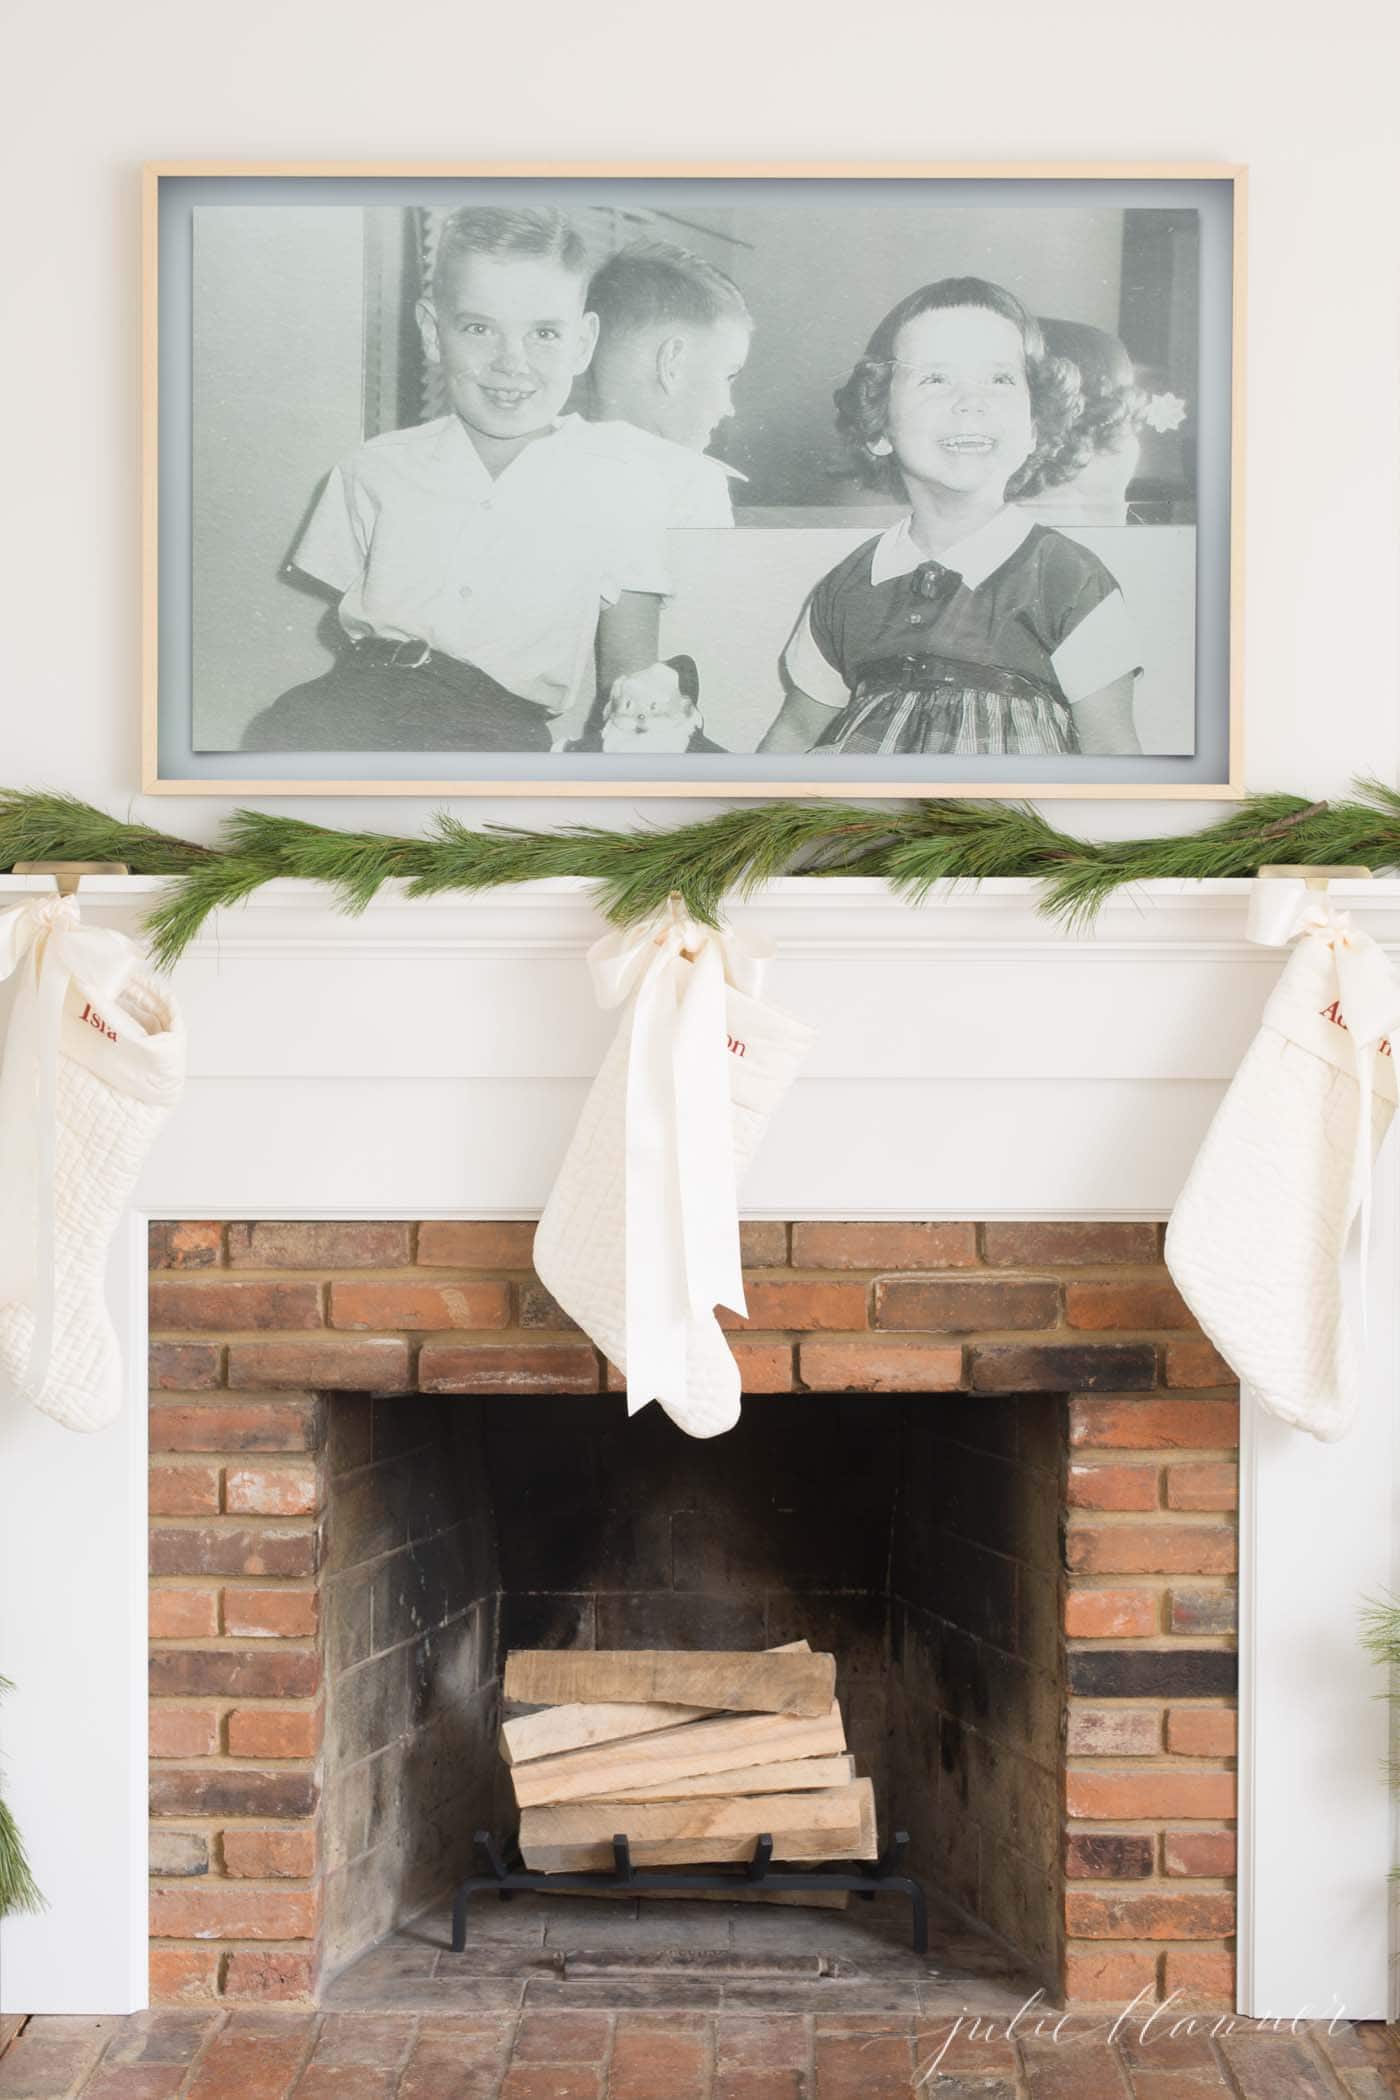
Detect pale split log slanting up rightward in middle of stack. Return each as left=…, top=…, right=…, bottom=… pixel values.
left=510, top=1699, right=846, bottom=1808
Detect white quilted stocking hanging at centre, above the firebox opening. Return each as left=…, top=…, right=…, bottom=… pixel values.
left=535, top=919, right=812, bottom=1436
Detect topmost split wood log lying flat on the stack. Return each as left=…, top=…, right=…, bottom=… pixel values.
left=504, top=1649, right=835, bottom=1714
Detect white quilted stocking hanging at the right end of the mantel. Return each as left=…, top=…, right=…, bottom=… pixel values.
left=1167, top=926, right=1396, bottom=1441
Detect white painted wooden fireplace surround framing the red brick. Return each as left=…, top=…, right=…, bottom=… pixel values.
left=0, top=876, right=1400, bottom=2018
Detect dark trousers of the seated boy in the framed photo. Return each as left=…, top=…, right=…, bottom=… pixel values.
left=241, top=653, right=550, bottom=752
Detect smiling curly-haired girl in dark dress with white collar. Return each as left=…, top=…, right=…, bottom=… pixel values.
left=760, top=277, right=1142, bottom=756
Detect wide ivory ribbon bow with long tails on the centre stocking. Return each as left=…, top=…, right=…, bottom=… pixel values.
left=588, top=897, right=772, bottom=1415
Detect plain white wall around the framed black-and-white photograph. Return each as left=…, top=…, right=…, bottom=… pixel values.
left=0, top=0, right=1400, bottom=836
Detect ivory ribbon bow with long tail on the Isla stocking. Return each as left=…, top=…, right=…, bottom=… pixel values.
left=0, top=897, right=141, bottom=1394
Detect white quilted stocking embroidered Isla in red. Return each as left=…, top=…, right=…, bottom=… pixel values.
left=0, top=935, right=185, bottom=1430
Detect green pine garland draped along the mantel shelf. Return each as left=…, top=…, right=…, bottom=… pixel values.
left=0, top=779, right=1400, bottom=966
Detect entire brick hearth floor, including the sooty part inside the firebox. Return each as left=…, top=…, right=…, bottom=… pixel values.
left=10, top=1896, right=1400, bottom=2100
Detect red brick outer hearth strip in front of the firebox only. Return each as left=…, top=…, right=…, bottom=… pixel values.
left=0, top=2010, right=1400, bottom=2100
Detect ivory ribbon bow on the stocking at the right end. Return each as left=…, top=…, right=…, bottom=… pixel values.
left=1247, top=878, right=1400, bottom=1302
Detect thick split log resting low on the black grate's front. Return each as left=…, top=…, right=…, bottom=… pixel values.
left=521, top=1779, right=875, bottom=1873
